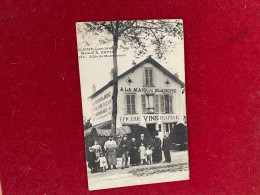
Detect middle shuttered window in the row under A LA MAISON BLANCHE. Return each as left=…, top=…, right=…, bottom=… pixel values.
left=142, top=94, right=159, bottom=113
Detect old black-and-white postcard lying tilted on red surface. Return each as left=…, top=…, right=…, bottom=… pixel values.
left=76, top=19, right=189, bottom=190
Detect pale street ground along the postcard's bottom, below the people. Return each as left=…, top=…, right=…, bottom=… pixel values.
left=88, top=151, right=189, bottom=190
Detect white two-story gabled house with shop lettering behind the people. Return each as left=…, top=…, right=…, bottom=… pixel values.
left=89, top=57, right=186, bottom=138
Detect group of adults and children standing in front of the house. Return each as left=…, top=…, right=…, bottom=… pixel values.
left=87, top=133, right=172, bottom=173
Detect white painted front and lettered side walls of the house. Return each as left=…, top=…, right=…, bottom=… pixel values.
left=91, top=63, right=186, bottom=138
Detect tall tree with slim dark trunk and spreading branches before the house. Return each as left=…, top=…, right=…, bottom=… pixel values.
left=77, top=20, right=183, bottom=136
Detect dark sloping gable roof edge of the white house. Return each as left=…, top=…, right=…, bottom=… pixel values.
left=89, top=56, right=185, bottom=98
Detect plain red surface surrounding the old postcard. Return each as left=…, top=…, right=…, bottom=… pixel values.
left=0, top=0, right=260, bottom=195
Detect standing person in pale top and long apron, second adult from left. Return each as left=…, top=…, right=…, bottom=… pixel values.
left=104, top=136, right=117, bottom=169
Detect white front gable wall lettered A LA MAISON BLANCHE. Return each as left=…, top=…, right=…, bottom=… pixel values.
left=117, top=63, right=186, bottom=137
